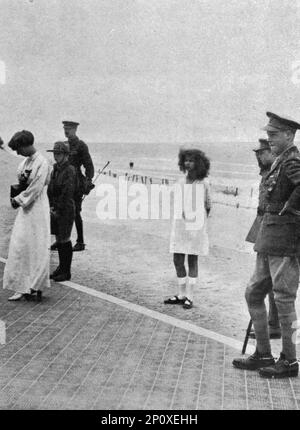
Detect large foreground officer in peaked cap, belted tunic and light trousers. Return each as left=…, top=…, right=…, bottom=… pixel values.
left=232, top=112, right=300, bottom=378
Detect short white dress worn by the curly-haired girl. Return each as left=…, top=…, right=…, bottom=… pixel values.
left=170, top=178, right=211, bottom=255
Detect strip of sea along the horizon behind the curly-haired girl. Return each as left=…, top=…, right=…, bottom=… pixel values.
left=89, top=142, right=258, bottom=180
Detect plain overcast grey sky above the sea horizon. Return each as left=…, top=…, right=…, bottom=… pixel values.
left=0, top=0, right=300, bottom=142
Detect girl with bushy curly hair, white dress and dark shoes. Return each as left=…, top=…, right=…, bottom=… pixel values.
left=164, top=149, right=211, bottom=309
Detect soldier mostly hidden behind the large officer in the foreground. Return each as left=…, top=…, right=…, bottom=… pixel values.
left=246, top=139, right=281, bottom=339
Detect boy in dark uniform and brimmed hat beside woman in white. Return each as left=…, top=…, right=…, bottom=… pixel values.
left=47, top=142, right=76, bottom=282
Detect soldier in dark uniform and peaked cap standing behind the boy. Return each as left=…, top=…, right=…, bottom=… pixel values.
left=51, top=121, right=94, bottom=251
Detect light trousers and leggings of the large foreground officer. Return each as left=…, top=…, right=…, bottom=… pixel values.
left=245, top=253, right=300, bottom=360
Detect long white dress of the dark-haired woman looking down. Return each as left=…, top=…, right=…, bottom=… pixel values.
left=3, top=152, right=50, bottom=293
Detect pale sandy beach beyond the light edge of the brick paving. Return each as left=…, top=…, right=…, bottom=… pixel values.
left=0, top=146, right=298, bottom=358
